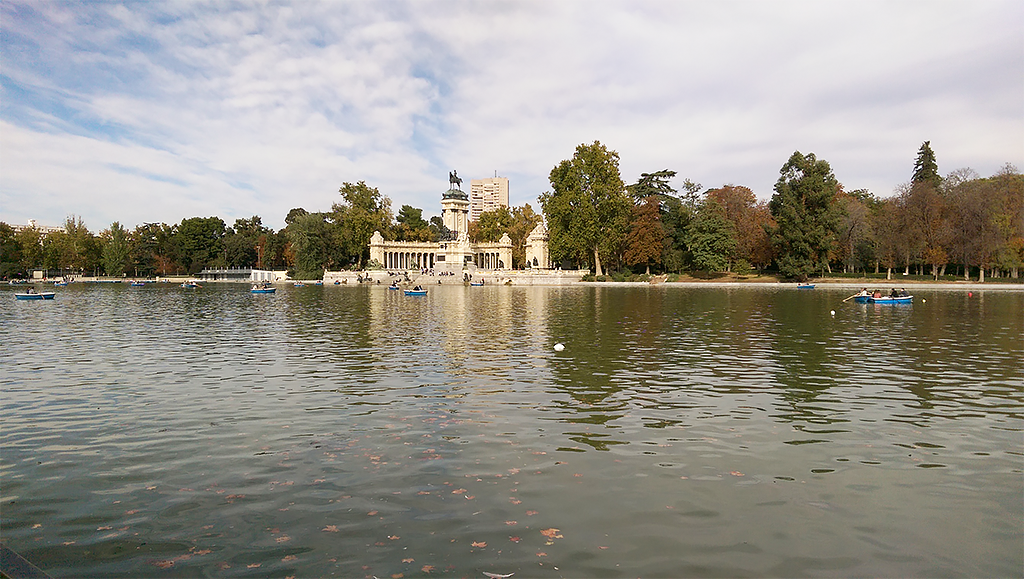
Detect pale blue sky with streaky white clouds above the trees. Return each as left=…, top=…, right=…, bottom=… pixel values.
left=0, top=0, right=1024, bottom=232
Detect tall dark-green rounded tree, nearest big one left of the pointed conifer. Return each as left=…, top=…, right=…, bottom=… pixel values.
left=768, top=151, right=842, bottom=279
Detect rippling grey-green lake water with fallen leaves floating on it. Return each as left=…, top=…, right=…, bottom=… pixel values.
left=0, top=284, right=1024, bottom=579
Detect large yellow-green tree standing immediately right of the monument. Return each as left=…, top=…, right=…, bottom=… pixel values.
left=540, top=140, right=631, bottom=275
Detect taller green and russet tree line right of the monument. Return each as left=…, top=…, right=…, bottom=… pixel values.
left=540, top=141, right=1024, bottom=281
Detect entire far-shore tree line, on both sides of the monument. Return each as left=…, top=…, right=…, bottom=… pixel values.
left=0, top=141, right=1024, bottom=281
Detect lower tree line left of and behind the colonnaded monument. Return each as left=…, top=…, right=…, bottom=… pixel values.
left=0, top=181, right=541, bottom=279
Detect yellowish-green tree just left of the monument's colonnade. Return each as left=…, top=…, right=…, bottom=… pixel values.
left=331, top=181, right=391, bottom=268
